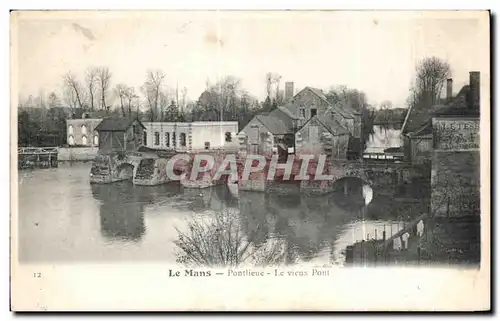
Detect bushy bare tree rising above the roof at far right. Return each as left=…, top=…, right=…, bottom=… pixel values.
left=414, top=57, right=451, bottom=108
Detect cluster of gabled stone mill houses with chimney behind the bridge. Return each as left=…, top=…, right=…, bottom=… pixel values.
left=239, top=82, right=361, bottom=158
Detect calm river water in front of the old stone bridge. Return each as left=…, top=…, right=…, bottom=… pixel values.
left=18, top=163, right=410, bottom=265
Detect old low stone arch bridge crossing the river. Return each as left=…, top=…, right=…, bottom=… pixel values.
left=90, top=151, right=414, bottom=194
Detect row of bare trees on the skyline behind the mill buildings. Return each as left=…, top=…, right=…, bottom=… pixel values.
left=19, top=67, right=412, bottom=149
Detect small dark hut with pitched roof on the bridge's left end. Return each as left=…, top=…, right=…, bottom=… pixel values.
left=95, top=117, right=146, bottom=153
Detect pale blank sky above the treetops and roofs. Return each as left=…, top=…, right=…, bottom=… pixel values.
left=11, top=11, right=487, bottom=107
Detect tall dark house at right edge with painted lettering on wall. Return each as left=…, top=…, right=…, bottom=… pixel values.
left=431, top=72, right=481, bottom=217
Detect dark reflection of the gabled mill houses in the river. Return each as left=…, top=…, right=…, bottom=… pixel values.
left=236, top=191, right=363, bottom=261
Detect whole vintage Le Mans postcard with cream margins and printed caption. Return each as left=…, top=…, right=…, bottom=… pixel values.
left=10, top=10, right=491, bottom=311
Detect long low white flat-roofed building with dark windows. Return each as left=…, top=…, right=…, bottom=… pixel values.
left=143, top=121, right=238, bottom=151
